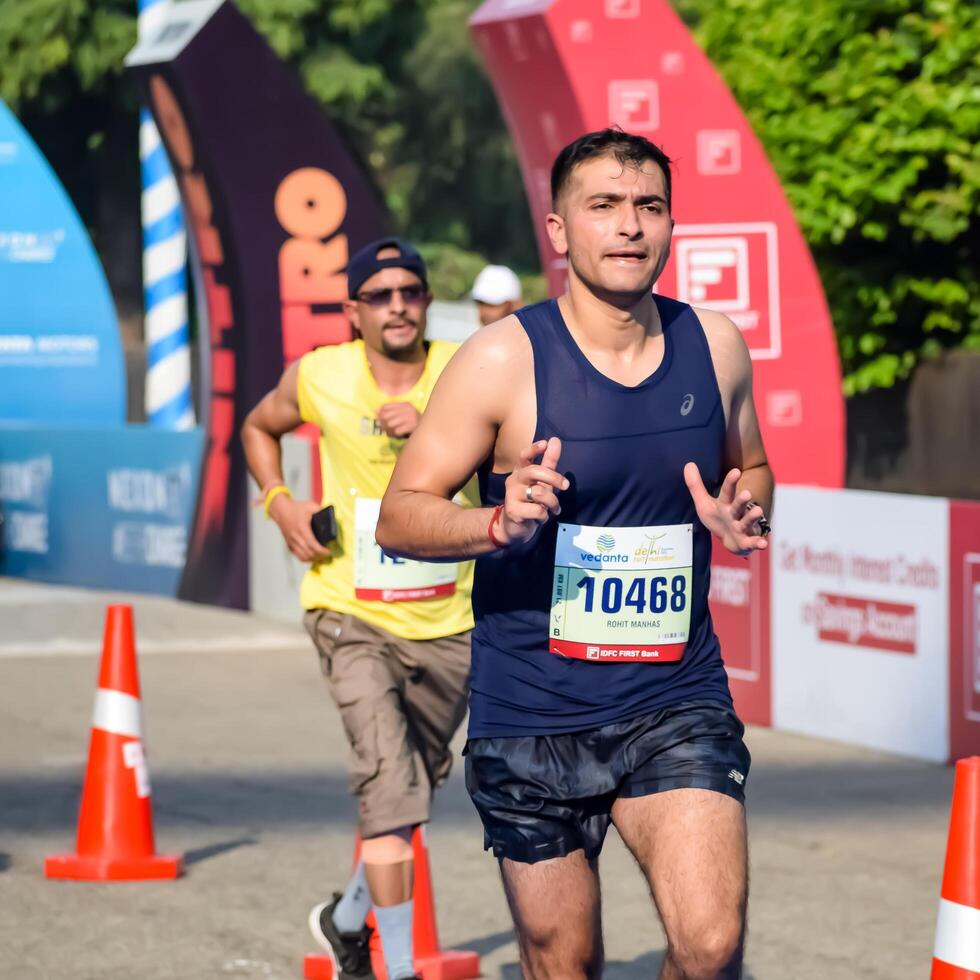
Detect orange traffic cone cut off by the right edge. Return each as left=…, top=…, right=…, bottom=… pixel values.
left=932, top=756, right=980, bottom=980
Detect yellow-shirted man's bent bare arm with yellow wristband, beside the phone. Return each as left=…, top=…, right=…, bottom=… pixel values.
left=242, top=361, right=330, bottom=561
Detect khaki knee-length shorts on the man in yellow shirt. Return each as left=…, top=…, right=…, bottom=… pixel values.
left=303, top=609, right=470, bottom=837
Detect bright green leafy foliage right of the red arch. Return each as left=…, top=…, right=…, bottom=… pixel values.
left=678, top=0, right=980, bottom=393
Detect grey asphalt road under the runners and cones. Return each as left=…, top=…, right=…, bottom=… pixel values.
left=0, top=579, right=952, bottom=980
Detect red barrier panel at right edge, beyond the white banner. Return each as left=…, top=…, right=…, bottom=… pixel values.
left=949, top=500, right=980, bottom=759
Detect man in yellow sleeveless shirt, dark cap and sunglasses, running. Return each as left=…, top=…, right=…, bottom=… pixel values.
left=242, top=238, right=476, bottom=980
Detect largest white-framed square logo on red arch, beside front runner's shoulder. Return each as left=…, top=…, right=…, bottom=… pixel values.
left=673, top=221, right=782, bottom=360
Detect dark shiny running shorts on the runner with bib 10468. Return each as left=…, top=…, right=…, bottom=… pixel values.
left=464, top=701, right=752, bottom=864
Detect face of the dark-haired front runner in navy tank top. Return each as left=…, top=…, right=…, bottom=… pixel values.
left=549, top=156, right=674, bottom=303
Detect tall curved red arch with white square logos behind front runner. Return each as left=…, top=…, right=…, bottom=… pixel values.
left=471, top=0, right=844, bottom=487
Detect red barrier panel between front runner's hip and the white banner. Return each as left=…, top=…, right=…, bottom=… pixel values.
left=708, top=546, right=772, bottom=725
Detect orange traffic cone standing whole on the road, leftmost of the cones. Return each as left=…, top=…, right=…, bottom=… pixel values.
left=44, top=606, right=183, bottom=881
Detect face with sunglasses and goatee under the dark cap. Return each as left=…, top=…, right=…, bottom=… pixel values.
left=345, top=266, right=432, bottom=358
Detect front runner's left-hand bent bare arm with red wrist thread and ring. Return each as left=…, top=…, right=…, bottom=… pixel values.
left=376, top=317, right=567, bottom=561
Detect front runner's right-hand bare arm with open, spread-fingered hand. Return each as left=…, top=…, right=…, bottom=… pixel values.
left=684, top=310, right=773, bottom=554
